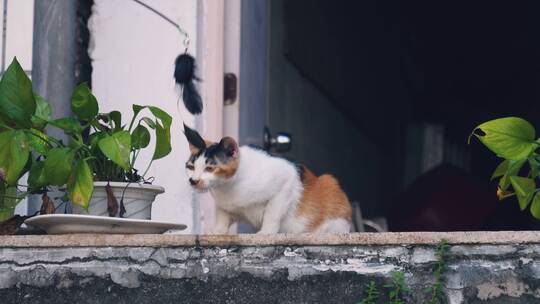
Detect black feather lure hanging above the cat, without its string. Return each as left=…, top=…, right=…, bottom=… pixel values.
left=174, top=53, right=203, bottom=114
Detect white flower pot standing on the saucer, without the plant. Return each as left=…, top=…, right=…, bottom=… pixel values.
left=73, top=182, right=165, bottom=220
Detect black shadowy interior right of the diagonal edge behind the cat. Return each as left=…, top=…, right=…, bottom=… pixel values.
left=270, top=0, right=540, bottom=230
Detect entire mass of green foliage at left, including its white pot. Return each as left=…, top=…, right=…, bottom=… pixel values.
left=0, top=58, right=172, bottom=219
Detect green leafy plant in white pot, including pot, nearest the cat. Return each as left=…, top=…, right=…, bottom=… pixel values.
left=64, top=87, right=172, bottom=219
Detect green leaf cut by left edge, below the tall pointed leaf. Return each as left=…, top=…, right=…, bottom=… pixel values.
left=0, top=130, right=30, bottom=185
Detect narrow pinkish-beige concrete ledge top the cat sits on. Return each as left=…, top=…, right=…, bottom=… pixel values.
left=0, top=231, right=540, bottom=248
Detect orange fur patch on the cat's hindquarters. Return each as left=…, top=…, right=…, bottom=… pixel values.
left=296, top=166, right=352, bottom=232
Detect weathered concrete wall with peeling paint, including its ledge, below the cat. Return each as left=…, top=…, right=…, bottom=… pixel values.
left=0, top=232, right=540, bottom=304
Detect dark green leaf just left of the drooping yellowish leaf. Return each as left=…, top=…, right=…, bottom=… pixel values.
left=45, top=148, right=75, bottom=186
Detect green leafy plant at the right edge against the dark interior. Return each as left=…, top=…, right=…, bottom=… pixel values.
left=469, top=117, right=540, bottom=219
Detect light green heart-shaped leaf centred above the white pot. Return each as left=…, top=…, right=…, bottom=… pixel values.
left=98, top=131, right=131, bottom=171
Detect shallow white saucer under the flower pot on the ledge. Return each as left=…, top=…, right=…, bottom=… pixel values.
left=25, top=214, right=187, bottom=234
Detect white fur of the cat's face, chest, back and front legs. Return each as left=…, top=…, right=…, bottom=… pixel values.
left=187, top=147, right=307, bottom=234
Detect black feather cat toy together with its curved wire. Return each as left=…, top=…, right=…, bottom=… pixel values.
left=133, top=0, right=203, bottom=114
